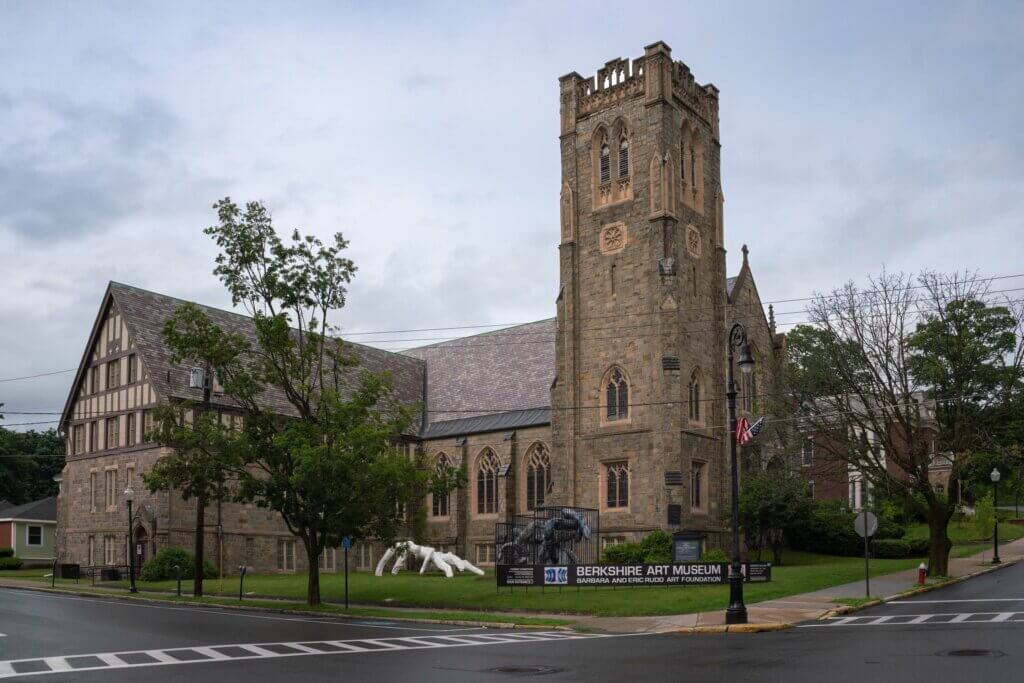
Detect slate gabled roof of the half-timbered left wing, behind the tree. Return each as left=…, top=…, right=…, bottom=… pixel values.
left=61, top=282, right=425, bottom=432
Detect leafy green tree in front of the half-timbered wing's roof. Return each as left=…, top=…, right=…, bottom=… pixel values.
left=151, top=199, right=454, bottom=605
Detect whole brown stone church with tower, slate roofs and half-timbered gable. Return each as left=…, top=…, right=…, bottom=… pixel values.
left=57, top=42, right=782, bottom=573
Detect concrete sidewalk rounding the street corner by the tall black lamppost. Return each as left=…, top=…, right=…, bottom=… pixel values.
left=574, top=539, right=1024, bottom=633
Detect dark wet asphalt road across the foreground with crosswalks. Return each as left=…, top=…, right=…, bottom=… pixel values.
left=0, top=564, right=1024, bottom=683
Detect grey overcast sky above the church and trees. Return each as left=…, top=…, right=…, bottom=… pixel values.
left=0, top=0, right=1024, bottom=424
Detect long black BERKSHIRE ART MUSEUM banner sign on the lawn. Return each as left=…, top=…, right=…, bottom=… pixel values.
left=497, top=562, right=771, bottom=587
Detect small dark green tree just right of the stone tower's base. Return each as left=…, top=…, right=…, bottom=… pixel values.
left=739, top=469, right=814, bottom=564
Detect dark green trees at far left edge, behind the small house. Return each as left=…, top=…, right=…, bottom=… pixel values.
left=0, top=403, right=65, bottom=505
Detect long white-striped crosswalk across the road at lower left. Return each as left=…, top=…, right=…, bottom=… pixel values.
left=0, top=631, right=610, bottom=679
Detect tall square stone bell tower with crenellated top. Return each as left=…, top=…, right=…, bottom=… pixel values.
left=552, top=42, right=727, bottom=545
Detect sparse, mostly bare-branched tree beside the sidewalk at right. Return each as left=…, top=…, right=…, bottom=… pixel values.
left=786, top=271, right=1021, bottom=575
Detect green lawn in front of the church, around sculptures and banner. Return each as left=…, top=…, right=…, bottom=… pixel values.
left=34, top=552, right=920, bottom=622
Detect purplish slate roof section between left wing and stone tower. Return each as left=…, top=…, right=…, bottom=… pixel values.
left=402, top=317, right=556, bottom=423
